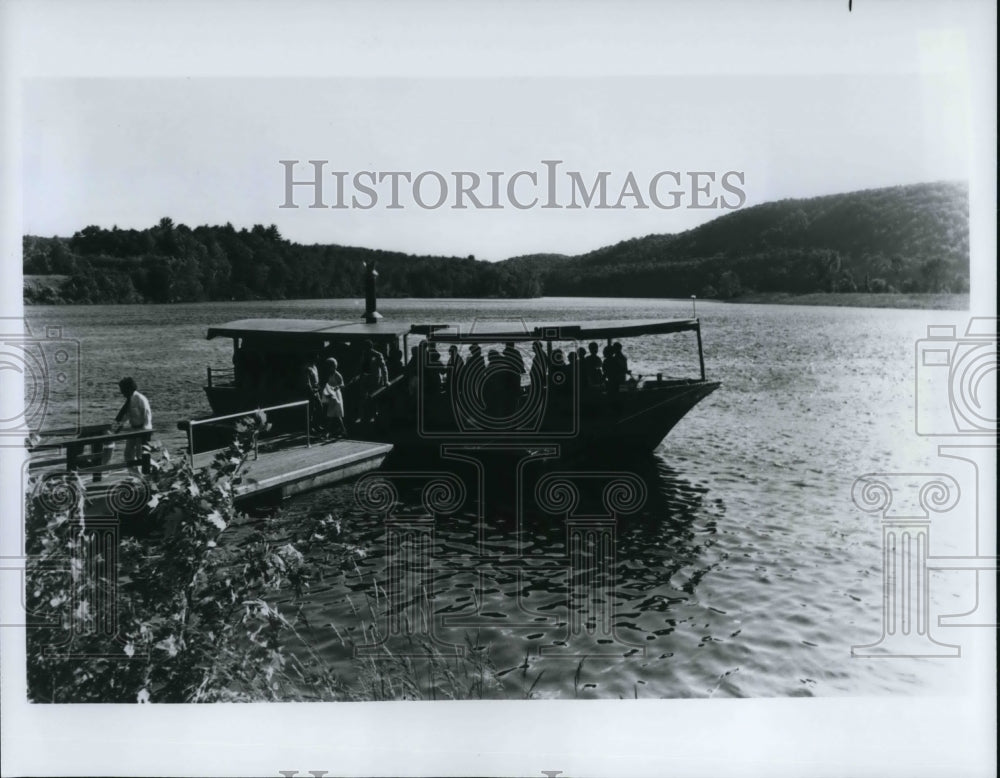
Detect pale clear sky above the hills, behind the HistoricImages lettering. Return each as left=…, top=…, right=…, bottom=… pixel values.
left=22, top=73, right=970, bottom=260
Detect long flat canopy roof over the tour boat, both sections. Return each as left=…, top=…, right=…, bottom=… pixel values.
left=208, top=319, right=700, bottom=343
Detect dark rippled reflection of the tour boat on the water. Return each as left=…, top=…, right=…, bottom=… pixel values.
left=288, top=449, right=724, bottom=697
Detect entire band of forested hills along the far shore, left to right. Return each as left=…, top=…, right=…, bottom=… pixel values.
left=24, top=183, right=969, bottom=303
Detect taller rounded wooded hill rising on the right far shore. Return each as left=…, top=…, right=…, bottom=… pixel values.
left=524, top=183, right=969, bottom=298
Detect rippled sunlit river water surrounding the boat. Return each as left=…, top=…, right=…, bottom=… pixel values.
left=28, top=299, right=984, bottom=698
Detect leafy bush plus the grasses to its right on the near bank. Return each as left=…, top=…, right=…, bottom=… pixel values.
left=26, top=418, right=500, bottom=702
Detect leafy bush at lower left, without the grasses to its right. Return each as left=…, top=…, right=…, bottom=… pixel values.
left=27, top=424, right=302, bottom=702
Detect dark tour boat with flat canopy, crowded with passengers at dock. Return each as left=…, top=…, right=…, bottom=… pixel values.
left=197, top=310, right=720, bottom=453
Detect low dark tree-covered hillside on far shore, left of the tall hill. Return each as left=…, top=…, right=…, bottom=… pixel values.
left=24, top=218, right=542, bottom=303
